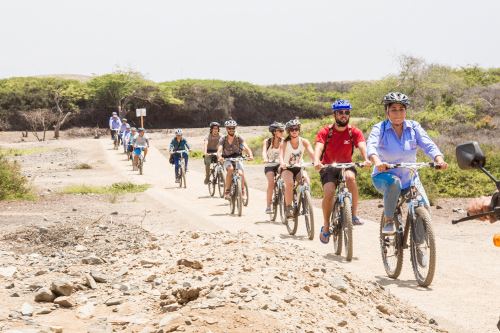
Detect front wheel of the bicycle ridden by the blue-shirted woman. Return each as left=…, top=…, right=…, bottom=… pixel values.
left=410, top=206, right=436, bottom=287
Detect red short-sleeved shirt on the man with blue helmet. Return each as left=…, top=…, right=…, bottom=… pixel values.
left=316, top=125, right=365, bottom=164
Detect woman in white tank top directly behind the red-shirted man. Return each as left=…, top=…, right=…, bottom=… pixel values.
left=280, top=118, right=314, bottom=218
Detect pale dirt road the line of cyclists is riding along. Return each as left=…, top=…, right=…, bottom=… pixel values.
left=2, top=132, right=500, bottom=332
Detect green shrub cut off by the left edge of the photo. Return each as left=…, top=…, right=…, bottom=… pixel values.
left=0, top=154, right=34, bottom=200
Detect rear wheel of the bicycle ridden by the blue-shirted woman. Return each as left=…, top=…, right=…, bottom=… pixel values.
left=380, top=211, right=403, bottom=279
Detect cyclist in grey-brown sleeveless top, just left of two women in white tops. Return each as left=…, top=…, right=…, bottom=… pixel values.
left=217, top=119, right=253, bottom=200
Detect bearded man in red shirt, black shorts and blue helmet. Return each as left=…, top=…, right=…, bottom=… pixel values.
left=314, top=99, right=371, bottom=243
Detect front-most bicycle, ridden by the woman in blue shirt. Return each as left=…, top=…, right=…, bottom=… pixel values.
left=380, top=162, right=438, bottom=287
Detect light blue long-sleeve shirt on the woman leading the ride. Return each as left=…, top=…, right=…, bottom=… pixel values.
left=366, top=120, right=443, bottom=188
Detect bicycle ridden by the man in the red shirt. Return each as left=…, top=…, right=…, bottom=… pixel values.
left=324, top=162, right=364, bottom=261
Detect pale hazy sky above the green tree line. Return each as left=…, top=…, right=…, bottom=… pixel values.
left=0, top=0, right=500, bottom=84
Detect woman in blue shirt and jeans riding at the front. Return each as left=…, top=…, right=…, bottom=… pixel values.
left=367, top=92, right=448, bottom=266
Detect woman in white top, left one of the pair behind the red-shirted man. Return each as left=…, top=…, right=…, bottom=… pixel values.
left=262, top=121, right=285, bottom=214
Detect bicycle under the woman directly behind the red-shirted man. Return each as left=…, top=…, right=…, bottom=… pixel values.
left=283, top=163, right=314, bottom=240
